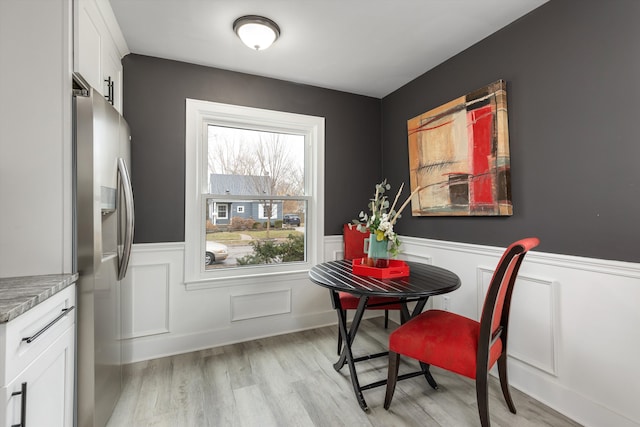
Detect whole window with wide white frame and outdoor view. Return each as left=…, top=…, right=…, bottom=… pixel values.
left=185, top=99, right=324, bottom=286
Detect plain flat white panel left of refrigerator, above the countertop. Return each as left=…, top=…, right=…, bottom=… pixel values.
left=0, top=0, right=73, bottom=277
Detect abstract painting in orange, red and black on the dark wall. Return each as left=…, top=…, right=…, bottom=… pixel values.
left=407, top=80, right=513, bottom=216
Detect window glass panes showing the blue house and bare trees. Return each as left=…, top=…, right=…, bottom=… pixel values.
left=204, top=124, right=306, bottom=270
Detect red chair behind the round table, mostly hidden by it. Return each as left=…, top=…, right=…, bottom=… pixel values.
left=338, top=224, right=401, bottom=354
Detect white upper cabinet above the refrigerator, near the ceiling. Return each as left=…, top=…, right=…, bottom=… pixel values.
left=73, top=0, right=129, bottom=113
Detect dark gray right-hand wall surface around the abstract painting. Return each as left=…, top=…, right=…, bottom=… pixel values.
left=382, top=0, right=640, bottom=262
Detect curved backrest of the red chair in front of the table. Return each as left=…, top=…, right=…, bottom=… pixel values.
left=478, top=237, right=540, bottom=365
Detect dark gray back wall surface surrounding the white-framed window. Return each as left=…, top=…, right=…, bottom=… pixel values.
left=122, top=54, right=382, bottom=243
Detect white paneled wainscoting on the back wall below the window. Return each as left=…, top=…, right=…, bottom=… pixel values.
left=123, top=239, right=341, bottom=363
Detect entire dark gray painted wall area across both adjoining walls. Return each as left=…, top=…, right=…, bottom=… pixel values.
left=123, top=0, right=640, bottom=262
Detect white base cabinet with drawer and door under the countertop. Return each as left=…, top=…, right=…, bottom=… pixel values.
left=0, top=285, right=75, bottom=427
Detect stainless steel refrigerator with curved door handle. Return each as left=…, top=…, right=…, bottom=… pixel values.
left=73, top=75, right=134, bottom=427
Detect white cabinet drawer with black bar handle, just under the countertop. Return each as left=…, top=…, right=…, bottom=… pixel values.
left=3, top=284, right=76, bottom=384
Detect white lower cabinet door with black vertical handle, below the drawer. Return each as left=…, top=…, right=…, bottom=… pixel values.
left=3, top=326, right=74, bottom=427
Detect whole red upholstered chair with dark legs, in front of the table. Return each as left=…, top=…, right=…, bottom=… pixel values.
left=384, top=237, right=539, bottom=427
